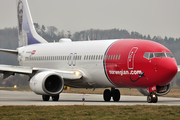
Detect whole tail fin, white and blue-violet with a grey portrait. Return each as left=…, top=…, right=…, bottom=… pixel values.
left=16, top=0, right=47, bottom=47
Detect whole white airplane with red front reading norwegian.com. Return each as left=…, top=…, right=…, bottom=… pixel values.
left=0, top=0, right=178, bottom=103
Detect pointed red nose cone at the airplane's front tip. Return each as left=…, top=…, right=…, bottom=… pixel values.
left=158, top=58, right=178, bottom=86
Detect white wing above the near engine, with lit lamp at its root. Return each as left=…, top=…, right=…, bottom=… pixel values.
left=0, top=65, right=83, bottom=80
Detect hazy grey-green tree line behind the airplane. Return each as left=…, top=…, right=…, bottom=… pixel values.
left=0, top=23, right=180, bottom=86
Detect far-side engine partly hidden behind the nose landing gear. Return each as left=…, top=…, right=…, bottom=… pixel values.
left=137, top=83, right=171, bottom=96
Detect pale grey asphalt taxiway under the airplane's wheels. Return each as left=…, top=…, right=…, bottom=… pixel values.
left=0, top=90, right=180, bottom=106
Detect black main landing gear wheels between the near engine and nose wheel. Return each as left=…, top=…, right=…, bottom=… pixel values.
left=103, top=88, right=121, bottom=102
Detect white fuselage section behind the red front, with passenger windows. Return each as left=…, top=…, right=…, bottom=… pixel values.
left=18, top=40, right=117, bottom=88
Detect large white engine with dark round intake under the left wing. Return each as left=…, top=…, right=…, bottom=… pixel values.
left=29, top=71, right=64, bottom=95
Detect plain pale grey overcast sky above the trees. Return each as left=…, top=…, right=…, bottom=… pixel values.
left=0, top=0, right=180, bottom=38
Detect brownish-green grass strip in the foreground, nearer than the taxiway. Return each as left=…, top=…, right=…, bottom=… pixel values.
left=0, top=105, right=180, bottom=120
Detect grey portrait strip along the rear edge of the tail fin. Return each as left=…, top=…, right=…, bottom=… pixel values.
left=17, top=0, right=28, bottom=47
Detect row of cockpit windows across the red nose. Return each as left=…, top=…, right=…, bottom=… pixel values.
left=144, top=52, right=174, bottom=59
